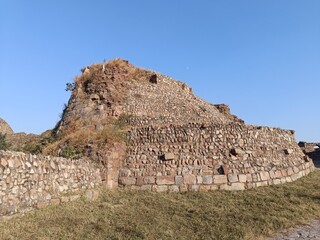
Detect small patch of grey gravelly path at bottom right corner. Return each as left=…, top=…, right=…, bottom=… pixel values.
left=266, top=220, right=320, bottom=240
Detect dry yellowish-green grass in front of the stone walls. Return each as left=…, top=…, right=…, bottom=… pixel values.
left=0, top=170, right=320, bottom=239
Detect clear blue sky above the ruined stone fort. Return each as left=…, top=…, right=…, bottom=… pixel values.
left=0, top=0, right=320, bottom=141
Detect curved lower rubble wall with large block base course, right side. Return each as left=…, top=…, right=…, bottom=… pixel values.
left=119, top=124, right=314, bottom=191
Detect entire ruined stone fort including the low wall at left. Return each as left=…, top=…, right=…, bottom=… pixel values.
left=0, top=59, right=314, bottom=215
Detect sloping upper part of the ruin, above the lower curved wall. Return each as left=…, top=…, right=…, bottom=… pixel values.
left=55, top=59, right=232, bottom=137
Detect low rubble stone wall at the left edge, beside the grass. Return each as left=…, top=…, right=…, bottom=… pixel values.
left=0, top=151, right=101, bottom=216
